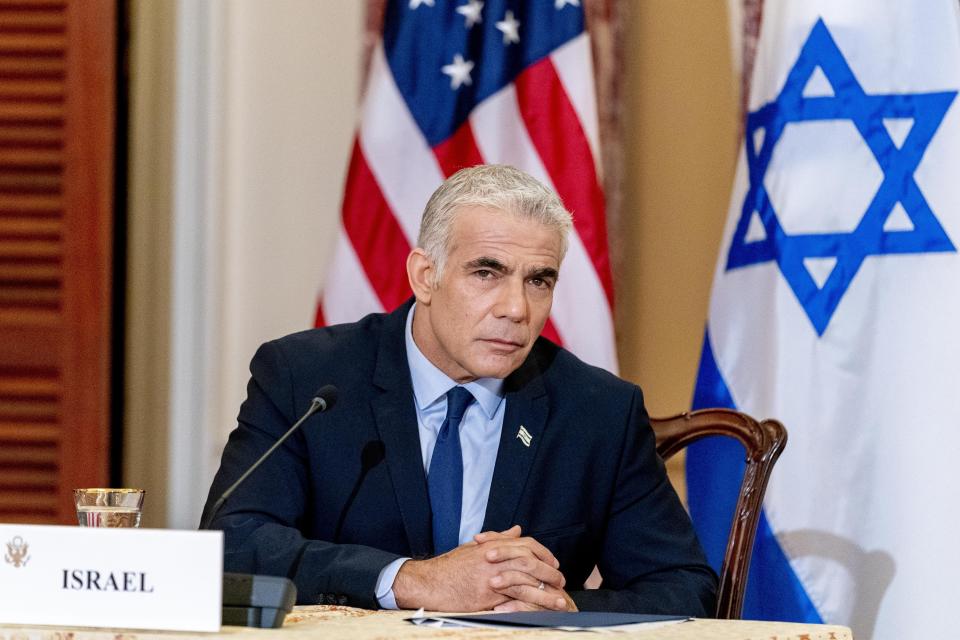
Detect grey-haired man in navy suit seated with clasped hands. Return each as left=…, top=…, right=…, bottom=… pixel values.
left=207, top=166, right=716, bottom=616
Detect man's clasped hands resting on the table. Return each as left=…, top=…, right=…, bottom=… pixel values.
left=393, top=525, right=576, bottom=611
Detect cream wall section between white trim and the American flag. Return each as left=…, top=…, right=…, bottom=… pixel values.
left=216, top=0, right=363, bottom=490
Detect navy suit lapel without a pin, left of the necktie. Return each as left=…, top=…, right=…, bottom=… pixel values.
left=371, top=302, right=433, bottom=557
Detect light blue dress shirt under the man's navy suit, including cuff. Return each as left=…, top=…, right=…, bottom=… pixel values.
left=377, top=304, right=507, bottom=609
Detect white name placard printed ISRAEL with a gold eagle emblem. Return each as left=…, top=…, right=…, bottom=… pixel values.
left=0, top=524, right=223, bottom=631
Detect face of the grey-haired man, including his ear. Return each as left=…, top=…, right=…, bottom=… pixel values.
left=408, top=207, right=561, bottom=382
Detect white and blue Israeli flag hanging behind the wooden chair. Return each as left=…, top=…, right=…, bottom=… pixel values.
left=687, top=0, right=960, bottom=640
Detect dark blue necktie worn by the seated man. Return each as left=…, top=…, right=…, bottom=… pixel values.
left=427, top=387, right=473, bottom=555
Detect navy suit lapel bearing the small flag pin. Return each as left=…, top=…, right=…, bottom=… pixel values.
left=483, top=357, right=548, bottom=531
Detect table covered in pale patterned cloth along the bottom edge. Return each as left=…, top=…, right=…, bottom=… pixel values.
left=0, top=606, right=853, bottom=640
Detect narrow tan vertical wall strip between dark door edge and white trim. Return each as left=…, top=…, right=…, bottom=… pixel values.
left=123, top=1, right=175, bottom=527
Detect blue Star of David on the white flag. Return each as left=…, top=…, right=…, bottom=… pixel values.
left=726, top=20, right=957, bottom=336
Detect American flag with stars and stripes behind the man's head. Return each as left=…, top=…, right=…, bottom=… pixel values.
left=316, top=0, right=617, bottom=372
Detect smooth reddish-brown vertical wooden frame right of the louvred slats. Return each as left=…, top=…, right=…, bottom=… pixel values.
left=59, top=0, right=117, bottom=513
